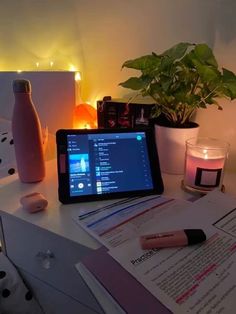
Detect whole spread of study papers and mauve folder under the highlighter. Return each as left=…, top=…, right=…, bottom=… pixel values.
left=74, top=191, right=236, bottom=314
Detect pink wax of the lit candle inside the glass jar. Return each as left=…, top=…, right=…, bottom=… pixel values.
left=184, top=154, right=225, bottom=189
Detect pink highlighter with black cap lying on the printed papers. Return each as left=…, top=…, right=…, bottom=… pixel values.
left=140, top=229, right=206, bottom=250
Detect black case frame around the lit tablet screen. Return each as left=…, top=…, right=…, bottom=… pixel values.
left=56, top=128, right=164, bottom=204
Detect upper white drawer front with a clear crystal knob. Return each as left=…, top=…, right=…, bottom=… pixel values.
left=2, top=215, right=102, bottom=313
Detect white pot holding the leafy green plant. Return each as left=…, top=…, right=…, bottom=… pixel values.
left=155, top=124, right=199, bottom=174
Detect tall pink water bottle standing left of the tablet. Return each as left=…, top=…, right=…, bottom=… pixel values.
left=12, top=79, right=45, bottom=183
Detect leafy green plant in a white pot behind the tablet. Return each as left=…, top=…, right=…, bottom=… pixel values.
left=119, top=42, right=236, bottom=174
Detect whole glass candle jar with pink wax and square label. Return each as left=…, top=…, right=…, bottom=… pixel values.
left=183, top=137, right=229, bottom=193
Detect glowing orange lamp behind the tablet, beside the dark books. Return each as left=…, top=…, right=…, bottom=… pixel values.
left=73, top=103, right=97, bottom=129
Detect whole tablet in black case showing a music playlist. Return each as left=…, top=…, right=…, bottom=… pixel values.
left=56, top=129, right=164, bottom=204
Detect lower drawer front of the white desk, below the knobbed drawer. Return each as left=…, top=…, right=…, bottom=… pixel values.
left=20, top=271, right=101, bottom=314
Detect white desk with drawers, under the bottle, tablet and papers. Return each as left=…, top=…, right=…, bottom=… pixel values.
left=0, top=161, right=236, bottom=314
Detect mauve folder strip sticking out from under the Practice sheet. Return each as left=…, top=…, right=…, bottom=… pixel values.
left=82, top=247, right=171, bottom=314
